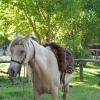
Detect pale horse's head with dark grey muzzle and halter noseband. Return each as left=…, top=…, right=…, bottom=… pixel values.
left=8, top=36, right=32, bottom=76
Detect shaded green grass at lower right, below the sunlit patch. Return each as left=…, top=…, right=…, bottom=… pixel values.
left=69, top=85, right=100, bottom=100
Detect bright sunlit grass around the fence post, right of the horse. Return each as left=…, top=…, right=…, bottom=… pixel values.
left=72, top=67, right=100, bottom=89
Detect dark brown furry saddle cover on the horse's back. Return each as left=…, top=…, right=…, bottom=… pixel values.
left=43, top=43, right=74, bottom=73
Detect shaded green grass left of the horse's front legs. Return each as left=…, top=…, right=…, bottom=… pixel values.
left=0, top=76, right=33, bottom=100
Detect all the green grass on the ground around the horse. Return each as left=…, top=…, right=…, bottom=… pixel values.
left=0, top=64, right=100, bottom=100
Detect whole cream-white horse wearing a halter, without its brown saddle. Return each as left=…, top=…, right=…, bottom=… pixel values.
left=8, top=36, right=71, bottom=100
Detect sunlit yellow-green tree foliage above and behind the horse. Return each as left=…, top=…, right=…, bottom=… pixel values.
left=0, top=0, right=100, bottom=57
